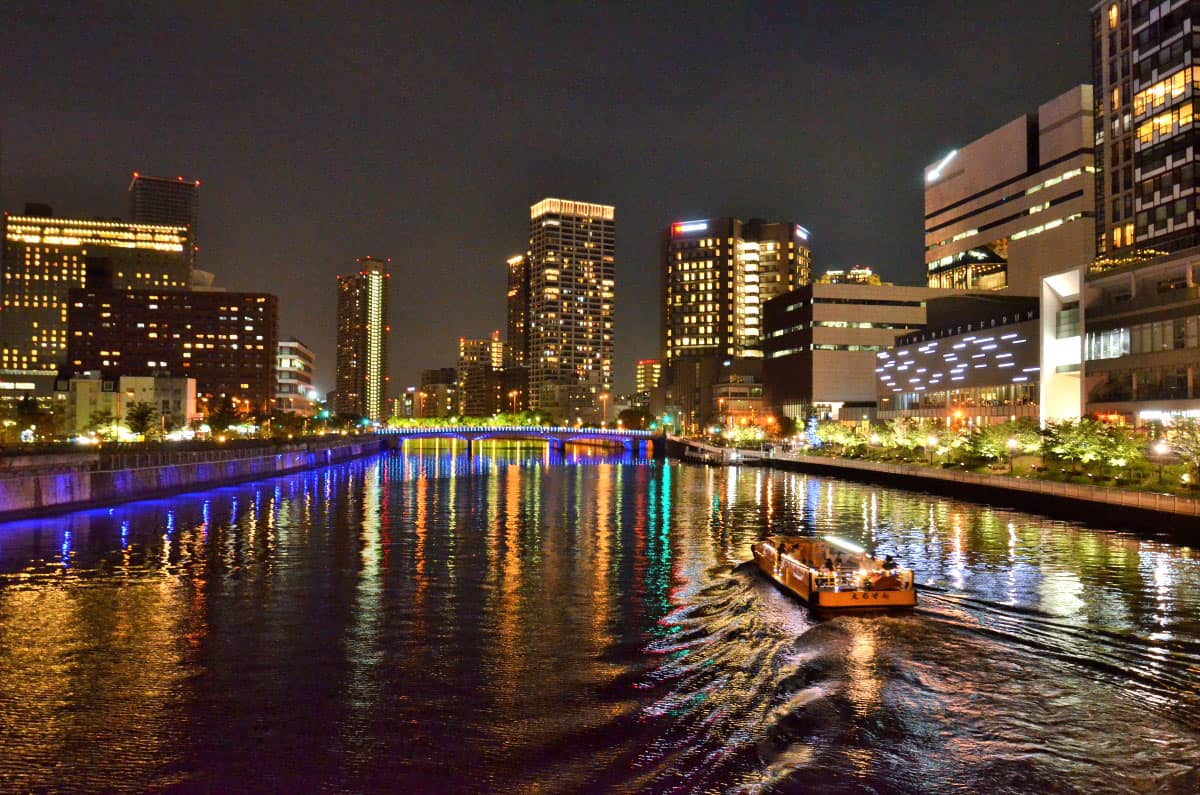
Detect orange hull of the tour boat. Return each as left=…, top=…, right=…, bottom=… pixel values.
left=752, top=537, right=917, bottom=611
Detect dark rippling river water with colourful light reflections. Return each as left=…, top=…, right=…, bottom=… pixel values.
left=0, top=444, right=1200, bottom=793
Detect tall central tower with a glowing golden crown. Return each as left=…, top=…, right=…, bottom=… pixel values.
left=528, top=198, right=616, bottom=417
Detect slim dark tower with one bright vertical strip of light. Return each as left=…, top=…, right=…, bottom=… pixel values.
left=335, top=257, right=391, bottom=420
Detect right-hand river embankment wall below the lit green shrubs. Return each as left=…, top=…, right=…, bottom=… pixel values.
left=667, top=438, right=1200, bottom=542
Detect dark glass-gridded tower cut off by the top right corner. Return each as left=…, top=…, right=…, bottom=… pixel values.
left=1092, top=0, right=1200, bottom=256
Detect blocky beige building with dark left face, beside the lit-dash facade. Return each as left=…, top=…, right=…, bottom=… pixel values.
left=763, top=285, right=954, bottom=422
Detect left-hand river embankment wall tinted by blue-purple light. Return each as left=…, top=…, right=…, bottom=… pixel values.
left=0, top=437, right=388, bottom=521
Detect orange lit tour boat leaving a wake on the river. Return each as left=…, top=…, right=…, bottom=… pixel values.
left=751, top=536, right=917, bottom=610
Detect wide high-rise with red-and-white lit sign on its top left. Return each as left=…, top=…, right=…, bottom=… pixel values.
left=660, top=217, right=811, bottom=367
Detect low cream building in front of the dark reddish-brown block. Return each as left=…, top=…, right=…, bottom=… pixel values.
left=62, top=372, right=200, bottom=436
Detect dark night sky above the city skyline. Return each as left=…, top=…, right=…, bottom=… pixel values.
left=0, top=0, right=1092, bottom=390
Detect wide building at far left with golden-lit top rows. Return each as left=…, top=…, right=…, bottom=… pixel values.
left=0, top=208, right=191, bottom=396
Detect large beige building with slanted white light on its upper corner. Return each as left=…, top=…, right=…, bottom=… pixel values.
left=925, top=85, right=1096, bottom=295
